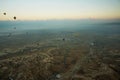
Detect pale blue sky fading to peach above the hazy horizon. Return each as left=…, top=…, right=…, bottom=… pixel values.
left=0, top=0, right=120, bottom=20
